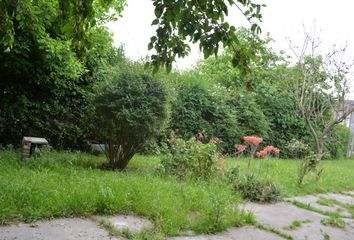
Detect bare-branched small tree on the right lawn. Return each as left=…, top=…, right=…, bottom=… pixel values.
left=291, top=33, right=354, bottom=161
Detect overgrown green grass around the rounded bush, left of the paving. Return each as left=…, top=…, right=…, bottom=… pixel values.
left=0, top=152, right=254, bottom=235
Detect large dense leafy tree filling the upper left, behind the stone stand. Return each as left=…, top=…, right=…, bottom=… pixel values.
left=0, top=0, right=124, bottom=147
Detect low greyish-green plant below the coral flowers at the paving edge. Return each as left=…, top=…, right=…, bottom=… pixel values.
left=229, top=170, right=280, bottom=202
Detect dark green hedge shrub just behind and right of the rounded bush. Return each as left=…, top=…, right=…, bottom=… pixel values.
left=170, top=84, right=243, bottom=151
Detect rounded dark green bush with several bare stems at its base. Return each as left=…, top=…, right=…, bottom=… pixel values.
left=95, top=71, right=168, bottom=169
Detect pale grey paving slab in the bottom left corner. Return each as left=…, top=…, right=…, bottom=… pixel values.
left=0, top=218, right=120, bottom=240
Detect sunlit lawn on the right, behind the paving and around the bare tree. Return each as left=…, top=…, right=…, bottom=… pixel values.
left=228, top=158, right=354, bottom=197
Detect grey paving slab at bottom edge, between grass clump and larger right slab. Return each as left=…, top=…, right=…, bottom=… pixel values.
left=168, top=226, right=283, bottom=240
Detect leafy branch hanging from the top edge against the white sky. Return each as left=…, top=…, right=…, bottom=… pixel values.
left=149, top=0, right=265, bottom=70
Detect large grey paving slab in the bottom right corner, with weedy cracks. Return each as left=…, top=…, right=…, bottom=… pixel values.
left=245, top=202, right=354, bottom=240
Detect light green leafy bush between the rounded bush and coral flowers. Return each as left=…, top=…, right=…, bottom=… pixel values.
left=161, top=133, right=220, bottom=179
